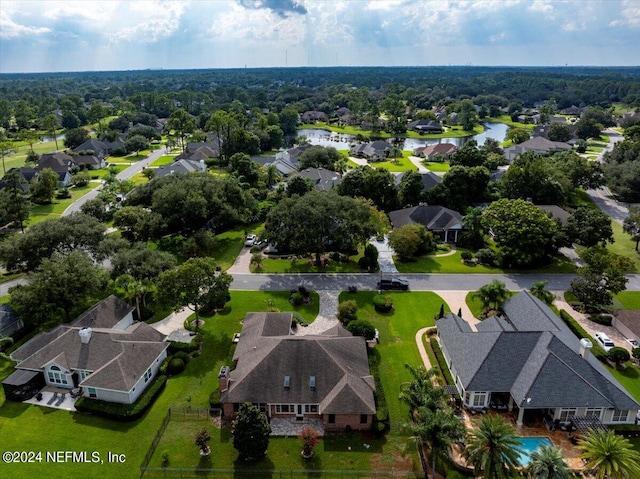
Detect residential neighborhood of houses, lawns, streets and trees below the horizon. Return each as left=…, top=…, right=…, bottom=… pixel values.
left=0, top=61, right=640, bottom=477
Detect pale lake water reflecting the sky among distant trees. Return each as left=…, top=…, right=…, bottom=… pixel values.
left=298, top=123, right=509, bottom=150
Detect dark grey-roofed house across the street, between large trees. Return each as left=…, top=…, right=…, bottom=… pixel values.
left=389, top=205, right=462, bottom=243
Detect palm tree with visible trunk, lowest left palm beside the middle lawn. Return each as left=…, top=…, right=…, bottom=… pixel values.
left=407, top=405, right=465, bottom=477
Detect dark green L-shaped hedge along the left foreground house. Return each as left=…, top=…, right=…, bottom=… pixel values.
left=75, top=375, right=167, bottom=421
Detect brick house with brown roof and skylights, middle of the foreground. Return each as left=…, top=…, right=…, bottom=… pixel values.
left=219, top=313, right=376, bottom=431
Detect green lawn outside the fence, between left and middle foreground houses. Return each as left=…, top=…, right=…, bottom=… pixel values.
left=0, top=291, right=320, bottom=479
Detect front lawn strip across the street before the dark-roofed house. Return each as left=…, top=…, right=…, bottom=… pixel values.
left=394, top=249, right=576, bottom=273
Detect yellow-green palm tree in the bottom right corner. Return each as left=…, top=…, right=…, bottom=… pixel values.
left=578, top=429, right=640, bottom=479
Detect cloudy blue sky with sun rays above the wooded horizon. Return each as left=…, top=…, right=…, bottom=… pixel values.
left=0, top=0, right=640, bottom=73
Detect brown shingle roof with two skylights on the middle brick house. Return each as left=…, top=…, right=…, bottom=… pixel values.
left=221, top=313, right=375, bottom=414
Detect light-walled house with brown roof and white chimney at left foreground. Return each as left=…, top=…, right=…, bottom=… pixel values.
left=2, top=296, right=169, bottom=404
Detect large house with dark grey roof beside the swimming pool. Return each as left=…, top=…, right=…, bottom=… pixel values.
left=436, top=292, right=640, bottom=425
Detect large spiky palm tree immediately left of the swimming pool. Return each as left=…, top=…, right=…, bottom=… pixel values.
left=465, top=415, right=521, bottom=479
